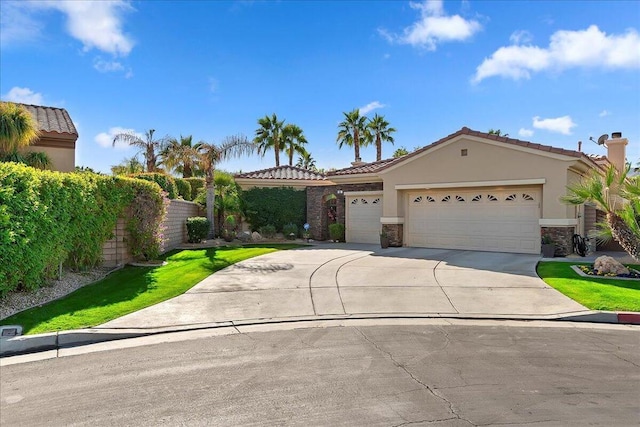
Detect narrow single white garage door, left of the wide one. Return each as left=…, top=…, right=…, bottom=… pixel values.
left=345, top=194, right=382, bottom=244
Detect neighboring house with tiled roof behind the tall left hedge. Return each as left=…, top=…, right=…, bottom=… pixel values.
left=18, top=104, right=78, bottom=172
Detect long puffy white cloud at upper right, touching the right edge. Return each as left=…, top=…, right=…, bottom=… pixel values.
left=473, top=25, right=640, bottom=83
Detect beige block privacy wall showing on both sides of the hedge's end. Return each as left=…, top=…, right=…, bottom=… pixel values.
left=102, top=200, right=204, bottom=267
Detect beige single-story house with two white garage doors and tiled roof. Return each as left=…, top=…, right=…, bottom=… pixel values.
left=241, top=127, right=628, bottom=255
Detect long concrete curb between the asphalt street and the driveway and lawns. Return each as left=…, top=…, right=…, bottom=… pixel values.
left=0, top=311, right=640, bottom=358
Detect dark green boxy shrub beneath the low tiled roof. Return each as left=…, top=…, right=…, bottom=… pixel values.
left=240, top=187, right=307, bottom=231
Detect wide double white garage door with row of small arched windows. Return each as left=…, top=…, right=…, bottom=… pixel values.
left=407, top=188, right=540, bottom=254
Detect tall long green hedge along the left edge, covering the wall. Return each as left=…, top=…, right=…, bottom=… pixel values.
left=0, top=163, right=165, bottom=296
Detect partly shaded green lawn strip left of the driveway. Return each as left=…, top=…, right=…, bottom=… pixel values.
left=1, top=244, right=301, bottom=334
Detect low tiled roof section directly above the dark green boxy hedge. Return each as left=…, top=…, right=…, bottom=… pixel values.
left=234, top=165, right=333, bottom=190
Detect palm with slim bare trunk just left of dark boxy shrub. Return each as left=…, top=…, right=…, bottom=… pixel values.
left=200, top=135, right=255, bottom=237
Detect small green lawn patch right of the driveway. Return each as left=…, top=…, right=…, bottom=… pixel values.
left=538, top=262, right=640, bottom=311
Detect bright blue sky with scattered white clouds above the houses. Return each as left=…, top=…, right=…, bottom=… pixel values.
left=0, top=0, right=640, bottom=172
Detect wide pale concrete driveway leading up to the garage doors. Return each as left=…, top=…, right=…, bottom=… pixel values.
left=99, top=244, right=588, bottom=329
